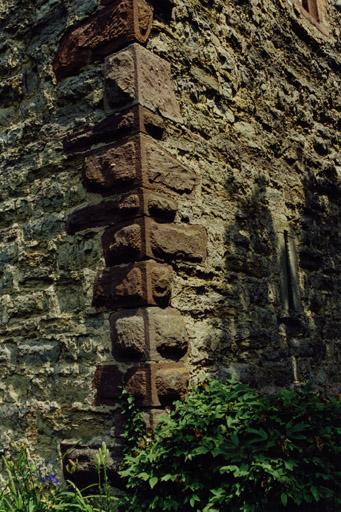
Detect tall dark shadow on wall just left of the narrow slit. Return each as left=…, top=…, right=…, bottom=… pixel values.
left=215, top=175, right=292, bottom=387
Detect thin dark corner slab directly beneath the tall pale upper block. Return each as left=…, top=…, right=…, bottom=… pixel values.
left=63, top=105, right=164, bottom=153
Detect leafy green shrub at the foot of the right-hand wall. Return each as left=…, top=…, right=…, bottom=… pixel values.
left=119, top=380, right=341, bottom=512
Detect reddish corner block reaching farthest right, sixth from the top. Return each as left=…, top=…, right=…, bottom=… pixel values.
left=102, top=217, right=207, bottom=266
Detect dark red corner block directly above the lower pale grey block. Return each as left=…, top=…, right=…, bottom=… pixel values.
left=93, top=261, right=172, bottom=308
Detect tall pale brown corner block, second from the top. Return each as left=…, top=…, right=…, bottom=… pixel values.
left=105, top=44, right=181, bottom=121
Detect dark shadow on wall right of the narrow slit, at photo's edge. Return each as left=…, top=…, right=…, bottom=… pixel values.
left=297, top=166, right=341, bottom=392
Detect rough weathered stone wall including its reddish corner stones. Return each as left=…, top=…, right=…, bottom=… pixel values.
left=0, top=0, right=341, bottom=480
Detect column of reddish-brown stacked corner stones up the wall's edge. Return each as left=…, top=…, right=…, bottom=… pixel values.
left=54, top=0, right=207, bottom=456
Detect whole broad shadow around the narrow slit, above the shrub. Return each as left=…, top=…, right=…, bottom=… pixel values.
left=203, top=164, right=341, bottom=390
